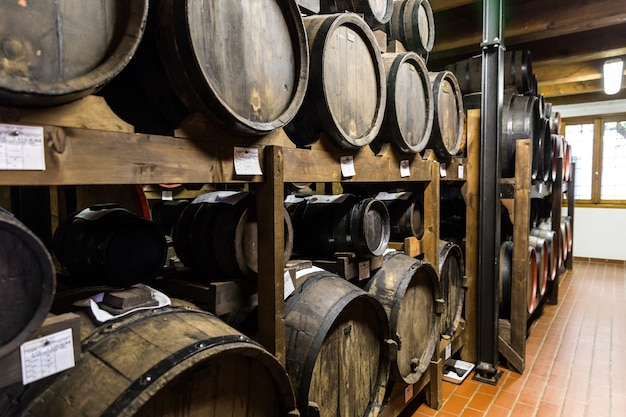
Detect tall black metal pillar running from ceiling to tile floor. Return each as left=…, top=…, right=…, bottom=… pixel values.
left=477, top=0, right=504, bottom=380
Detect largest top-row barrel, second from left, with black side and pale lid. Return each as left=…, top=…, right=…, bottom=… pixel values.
left=104, top=0, right=309, bottom=135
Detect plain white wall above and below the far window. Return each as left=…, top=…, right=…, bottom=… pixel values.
left=552, top=100, right=626, bottom=261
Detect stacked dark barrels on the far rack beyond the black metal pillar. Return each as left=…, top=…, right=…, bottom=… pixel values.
left=447, top=50, right=571, bottom=319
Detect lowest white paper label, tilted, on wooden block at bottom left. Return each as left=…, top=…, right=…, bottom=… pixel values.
left=20, top=329, right=74, bottom=385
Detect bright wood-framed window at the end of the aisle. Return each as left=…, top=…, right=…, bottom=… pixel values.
left=564, top=115, right=626, bottom=206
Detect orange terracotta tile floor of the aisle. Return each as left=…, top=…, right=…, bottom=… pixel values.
left=412, top=261, right=626, bottom=417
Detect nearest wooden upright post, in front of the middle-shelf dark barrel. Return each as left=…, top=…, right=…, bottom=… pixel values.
left=256, top=146, right=285, bottom=366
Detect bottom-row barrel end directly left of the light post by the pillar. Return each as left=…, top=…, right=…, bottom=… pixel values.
left=439, top=241, right=467, bottom=336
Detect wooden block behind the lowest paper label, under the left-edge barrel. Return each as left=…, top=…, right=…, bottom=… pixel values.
left=0, top=313, right=81, bottom=388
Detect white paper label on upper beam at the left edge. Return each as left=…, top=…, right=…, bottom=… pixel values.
left=0, top=125, right=46, bottom=171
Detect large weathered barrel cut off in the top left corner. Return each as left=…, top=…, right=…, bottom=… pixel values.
left=0, top=0, right=148, bottom=106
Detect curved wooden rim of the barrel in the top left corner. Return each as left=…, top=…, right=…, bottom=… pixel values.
left=0, top=0, right=149, bottom=106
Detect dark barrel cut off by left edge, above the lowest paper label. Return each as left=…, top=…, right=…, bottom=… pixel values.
left=0, top=208, right=56, bottom=358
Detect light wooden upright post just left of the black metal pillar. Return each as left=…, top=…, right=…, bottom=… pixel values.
left=463, top=110, right=480, bottom=363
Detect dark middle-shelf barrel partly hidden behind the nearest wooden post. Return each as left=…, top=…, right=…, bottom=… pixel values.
left=172, top=191, right=294, bottom=281
